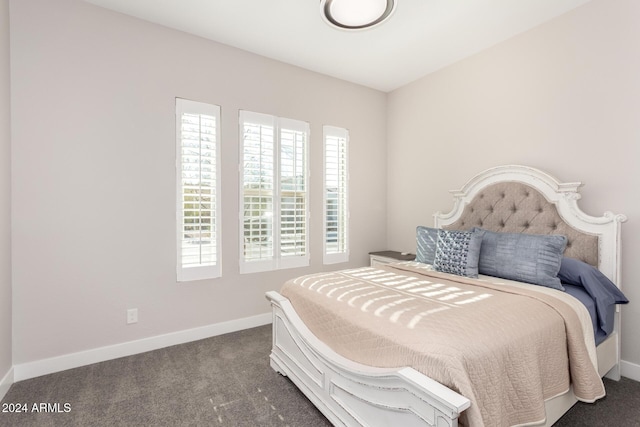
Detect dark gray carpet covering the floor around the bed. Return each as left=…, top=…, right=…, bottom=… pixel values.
left=0, top=325, right=640, bottom=427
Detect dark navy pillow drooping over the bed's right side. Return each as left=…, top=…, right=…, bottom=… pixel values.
left=558, top=257, right=629, bottom=334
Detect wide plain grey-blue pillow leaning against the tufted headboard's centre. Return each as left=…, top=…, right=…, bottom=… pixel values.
left=474, top=227, right=567, bottom=291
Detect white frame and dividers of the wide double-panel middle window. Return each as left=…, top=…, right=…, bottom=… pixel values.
left=238, top=110, right=310, bottom=274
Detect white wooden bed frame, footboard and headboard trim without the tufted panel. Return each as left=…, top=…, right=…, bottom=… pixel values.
left=266, top=165, right=626, bottom=427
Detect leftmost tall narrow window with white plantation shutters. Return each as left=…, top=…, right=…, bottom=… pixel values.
left=176, top=98, right=221, bottom=282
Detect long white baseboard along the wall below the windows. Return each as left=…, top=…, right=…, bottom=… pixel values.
left=13, top=313, right=272, bottom=381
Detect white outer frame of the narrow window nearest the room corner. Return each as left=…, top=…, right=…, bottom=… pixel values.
left=322, top=125, right=350, bottom=264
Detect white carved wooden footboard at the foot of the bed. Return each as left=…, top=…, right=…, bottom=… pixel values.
left=266, top=291, right=471, bottom=427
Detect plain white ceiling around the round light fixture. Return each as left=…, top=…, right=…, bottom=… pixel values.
left=85, top=0, right=591, bottom=92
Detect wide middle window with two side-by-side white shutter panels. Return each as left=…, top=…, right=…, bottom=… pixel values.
left=240, top=111, right=309, bottom=273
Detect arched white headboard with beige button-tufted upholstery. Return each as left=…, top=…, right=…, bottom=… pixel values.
left=434, top=165, right=626, bottom=283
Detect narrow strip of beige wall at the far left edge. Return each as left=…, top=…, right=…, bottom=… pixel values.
left=0, top=0, right=12, bottom=382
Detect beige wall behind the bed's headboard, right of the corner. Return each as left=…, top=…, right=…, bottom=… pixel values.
left=387, top=0, right=640, bottom=364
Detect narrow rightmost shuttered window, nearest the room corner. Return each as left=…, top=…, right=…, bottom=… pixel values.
left=323, top=126, right=349, bottom=264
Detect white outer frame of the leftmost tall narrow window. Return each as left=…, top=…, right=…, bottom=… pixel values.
left=175, top=98, right=222, bottom=282
